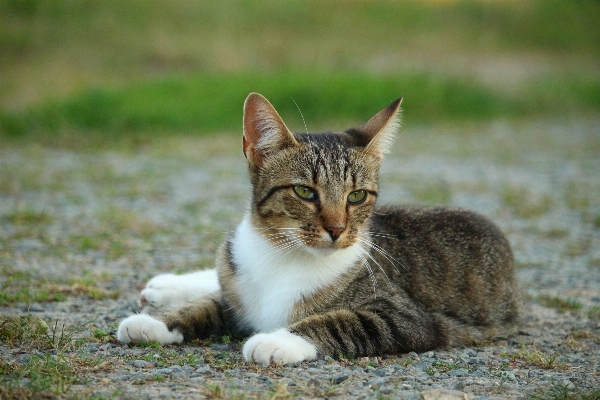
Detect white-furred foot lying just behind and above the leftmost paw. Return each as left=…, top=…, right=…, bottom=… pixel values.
left=140, top=269, right=220, bottom=313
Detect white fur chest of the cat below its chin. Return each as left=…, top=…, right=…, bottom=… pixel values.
left=232, top=218, right=362, bottom=332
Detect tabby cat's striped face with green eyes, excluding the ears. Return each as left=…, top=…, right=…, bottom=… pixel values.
left=253, top=133, right=379, bottom=250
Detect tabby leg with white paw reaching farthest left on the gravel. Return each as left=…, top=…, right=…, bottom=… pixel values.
left=117, top=291, right=225, bottom=344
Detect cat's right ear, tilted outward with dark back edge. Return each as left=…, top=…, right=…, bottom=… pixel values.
left=349, top=98, right=402, bottom=159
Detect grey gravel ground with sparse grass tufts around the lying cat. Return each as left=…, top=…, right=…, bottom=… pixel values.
left=0, top=120, right=600, bottom=399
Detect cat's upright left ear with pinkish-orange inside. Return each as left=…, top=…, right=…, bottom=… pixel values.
left=244, top=93, right=299, bottom=166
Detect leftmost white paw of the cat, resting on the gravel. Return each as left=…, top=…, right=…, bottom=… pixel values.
left=117, top=314, right=183, bottom=344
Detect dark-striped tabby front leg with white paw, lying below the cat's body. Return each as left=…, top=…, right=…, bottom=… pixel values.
left=244, top=299, right=450, bottom=364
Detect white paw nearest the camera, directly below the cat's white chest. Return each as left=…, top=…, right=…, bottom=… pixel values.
left=243, top=329, right=317, bottom=365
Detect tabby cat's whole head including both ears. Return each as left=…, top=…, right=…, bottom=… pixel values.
left=243, top=93, right=402, bottom=254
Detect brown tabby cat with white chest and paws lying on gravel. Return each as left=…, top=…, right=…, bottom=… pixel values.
left=117, top=93, right=519, bottom=365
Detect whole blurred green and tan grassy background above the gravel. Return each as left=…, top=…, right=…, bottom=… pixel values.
left=0, top=0, right=600, bottom=144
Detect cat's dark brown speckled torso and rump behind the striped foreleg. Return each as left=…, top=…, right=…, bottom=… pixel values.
left=370, top=207, right=518, bottom=325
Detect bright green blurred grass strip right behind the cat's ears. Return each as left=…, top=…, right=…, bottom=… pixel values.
left=0, top=70, right=600, bottom=141
